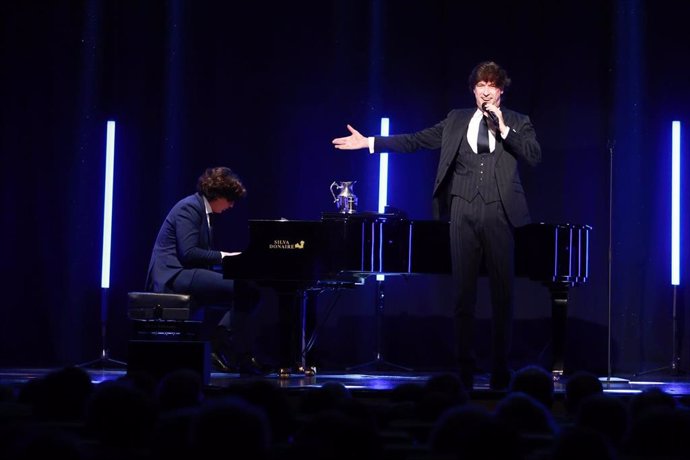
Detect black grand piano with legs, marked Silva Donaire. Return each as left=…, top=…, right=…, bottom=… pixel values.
left=222, top=212, right=591, bottom=379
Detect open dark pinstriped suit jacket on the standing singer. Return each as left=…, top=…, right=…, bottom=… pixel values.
left=374, top=108, right=541, bottom=227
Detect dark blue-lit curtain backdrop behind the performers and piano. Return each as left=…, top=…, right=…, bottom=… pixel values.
left=0, top=0, right=690, bottom=373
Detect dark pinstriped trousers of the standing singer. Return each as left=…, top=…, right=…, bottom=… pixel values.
left=450, top=195, right=515, bottom=372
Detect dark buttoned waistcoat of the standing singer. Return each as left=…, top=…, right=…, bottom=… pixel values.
left=450, top=136, right=500, bottom=203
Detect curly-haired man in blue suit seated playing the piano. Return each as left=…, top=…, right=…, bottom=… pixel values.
left=146, top=167, right=264, bottom=375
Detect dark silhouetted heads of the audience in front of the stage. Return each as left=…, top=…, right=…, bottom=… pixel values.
left=0, top=365, right=690, bottom=460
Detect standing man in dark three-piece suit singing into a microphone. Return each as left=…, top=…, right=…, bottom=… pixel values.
left=333, top=61, right=541, bottom=389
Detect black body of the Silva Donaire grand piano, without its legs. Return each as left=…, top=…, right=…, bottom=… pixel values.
left=223, top=217, right=591, bottom=285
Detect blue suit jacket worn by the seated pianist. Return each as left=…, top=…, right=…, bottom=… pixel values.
left=146, top=193, right=222, bottom=292
